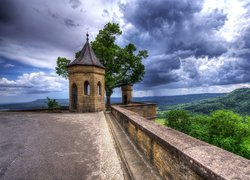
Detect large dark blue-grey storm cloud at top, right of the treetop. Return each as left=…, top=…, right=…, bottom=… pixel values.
left=122, top=0, right=226, bottom=57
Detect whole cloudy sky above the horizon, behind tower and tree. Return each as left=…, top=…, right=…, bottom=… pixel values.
left=0, top=0, right=250, bottom=103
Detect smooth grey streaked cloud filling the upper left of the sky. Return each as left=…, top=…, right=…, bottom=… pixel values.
left=0, top=0, right=90, bottom=69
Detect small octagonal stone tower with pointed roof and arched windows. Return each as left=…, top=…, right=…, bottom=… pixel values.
left=67, top=34, right=105, bottom=112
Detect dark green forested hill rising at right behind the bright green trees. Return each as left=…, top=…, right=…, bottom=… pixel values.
left=167, top=88, right=250, bottom=115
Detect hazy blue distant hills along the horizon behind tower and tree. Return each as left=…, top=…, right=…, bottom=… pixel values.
left=0, top=93, right=224, bottom=111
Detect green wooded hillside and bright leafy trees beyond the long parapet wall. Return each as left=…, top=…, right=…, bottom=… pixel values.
left=156, top=88, right=250, bottom=159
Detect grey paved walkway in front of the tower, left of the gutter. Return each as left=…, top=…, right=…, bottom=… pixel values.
left=0, top=113, right=124, bottom=180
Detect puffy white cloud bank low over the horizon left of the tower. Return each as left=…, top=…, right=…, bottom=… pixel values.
left=0, top=72, right=68, bottom=96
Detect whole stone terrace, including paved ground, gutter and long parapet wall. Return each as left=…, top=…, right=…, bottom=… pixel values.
left=0, top=109, right=250, bottom=180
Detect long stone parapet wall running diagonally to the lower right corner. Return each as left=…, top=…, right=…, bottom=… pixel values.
left=111, top=106, right=250, bottom=180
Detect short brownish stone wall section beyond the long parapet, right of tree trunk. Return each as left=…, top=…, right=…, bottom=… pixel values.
left=117, top=102, right=156, bottom=120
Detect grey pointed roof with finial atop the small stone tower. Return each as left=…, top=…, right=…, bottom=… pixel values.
left=68, top=34, right=105, bottom=69
